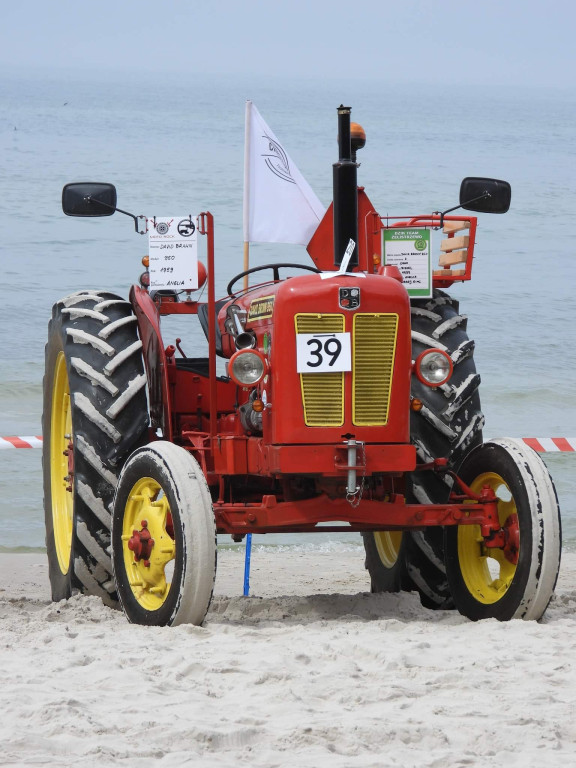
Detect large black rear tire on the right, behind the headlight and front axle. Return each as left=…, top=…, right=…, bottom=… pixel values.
left=363, top=290, right=484, bottom=609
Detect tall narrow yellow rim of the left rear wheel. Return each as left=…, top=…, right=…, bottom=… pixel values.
left=50, top=352, right=74, bottom=574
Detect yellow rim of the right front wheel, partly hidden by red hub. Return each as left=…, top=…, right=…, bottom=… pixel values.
left=458, top=472, right=517, bottom=605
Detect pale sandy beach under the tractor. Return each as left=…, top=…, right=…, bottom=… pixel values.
left=0, top=549, right=576, bottom=768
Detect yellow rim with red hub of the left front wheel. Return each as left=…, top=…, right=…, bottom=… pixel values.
left=122, top=477, right=176, bottom=611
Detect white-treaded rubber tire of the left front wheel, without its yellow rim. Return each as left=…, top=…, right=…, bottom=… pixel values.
left=112, top=441, right=217, bottom=626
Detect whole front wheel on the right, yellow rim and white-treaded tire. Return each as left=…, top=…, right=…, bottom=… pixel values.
left=445, top=438, right=561, bottom=621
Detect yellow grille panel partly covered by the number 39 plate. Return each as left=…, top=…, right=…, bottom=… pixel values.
left=294, top=313, right=344, bottom=427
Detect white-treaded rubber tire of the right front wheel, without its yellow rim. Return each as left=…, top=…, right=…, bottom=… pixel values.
left=446, top=438, right=562, bottom=621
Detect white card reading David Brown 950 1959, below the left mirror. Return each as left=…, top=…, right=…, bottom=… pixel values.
left=148, top=216, right=198, bottom=291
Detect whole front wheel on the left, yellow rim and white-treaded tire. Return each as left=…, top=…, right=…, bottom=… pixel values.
left=112, top=441, right=216, bottom=626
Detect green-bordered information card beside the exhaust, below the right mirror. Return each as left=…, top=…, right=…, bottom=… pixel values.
left=383, top=227, right=432, bottom=299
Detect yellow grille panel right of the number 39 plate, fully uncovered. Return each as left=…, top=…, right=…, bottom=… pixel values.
left=352, top=313, right=398, bottom=426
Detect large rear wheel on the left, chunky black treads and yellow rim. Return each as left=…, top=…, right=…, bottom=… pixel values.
left=42, top=291, right=148, bottom=606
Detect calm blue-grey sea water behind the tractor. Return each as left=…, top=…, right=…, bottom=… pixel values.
left=0, top=73, right=576, bottom=550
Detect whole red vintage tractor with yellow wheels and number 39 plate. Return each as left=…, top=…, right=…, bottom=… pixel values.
left=43, top=107, right=561, bottom=625
